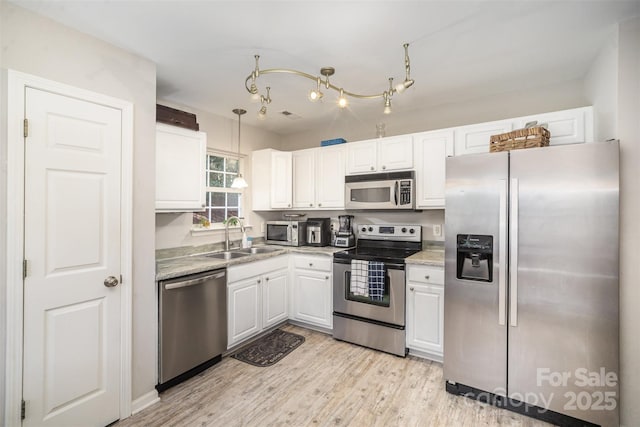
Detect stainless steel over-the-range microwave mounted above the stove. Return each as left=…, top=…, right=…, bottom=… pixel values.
left=345, top=171, right=415, bottom=209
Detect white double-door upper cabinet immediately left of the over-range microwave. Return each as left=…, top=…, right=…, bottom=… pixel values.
left=292, top=146, right=345, bottom=209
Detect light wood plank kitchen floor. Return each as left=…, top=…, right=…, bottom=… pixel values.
left=114, top=325, right=548, bottom=427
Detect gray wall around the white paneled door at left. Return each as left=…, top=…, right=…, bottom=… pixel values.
left=0, top=1, right=157, bottom=406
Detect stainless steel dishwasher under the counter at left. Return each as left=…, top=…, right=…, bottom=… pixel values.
left=156, top=269, right=227, bottom=391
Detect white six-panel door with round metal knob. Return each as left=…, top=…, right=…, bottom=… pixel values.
left=23, top=88, right=122, bottom=426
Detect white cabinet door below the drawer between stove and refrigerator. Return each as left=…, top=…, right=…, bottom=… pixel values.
left=407, top=282, right=444, bottom=360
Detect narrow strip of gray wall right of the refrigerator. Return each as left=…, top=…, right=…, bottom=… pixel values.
left=617, top=18, right=640, bottom=427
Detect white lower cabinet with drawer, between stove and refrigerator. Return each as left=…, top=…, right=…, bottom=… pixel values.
left=406, top=265, right=444, bottom=361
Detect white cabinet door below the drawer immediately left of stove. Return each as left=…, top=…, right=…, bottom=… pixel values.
left=292, top=270, right=333, bottom=328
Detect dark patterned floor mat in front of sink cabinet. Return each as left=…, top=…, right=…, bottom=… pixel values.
left=231, top=329, right=304, bottom=367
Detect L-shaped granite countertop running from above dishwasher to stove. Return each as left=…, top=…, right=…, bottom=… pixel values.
left=156, top=245, right=344, bottom=280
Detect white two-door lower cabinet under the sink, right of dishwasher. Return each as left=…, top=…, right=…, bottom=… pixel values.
left=227, top=255, right=289, bottom=349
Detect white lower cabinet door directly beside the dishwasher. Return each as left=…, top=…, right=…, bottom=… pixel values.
left=227, top=277, right=262, bottom=348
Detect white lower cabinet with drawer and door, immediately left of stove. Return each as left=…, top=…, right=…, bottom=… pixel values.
left=289, top=254, right=333, bottom=329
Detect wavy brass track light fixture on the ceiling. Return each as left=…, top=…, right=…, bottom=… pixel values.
left=244, top=43, right=414, bottom=119
